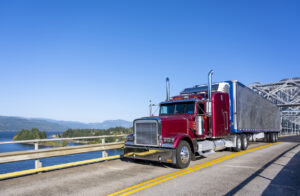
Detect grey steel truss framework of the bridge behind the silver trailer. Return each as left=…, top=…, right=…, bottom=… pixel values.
left=249, top=77, right=300, bottom=135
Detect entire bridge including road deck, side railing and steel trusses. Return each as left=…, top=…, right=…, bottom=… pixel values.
left=0, top=78, right=300, bottom=195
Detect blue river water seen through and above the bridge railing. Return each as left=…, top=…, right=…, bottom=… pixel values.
left=0, top=132, right=123, bottom=174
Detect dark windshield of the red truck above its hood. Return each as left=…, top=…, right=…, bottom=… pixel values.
left=160, top=102, right=195, bottom=115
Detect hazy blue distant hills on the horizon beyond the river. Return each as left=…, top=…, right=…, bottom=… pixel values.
left=0, top=116, right=132, bottom=132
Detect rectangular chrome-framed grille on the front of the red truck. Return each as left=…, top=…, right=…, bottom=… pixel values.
left=134, top=120, right=158, bottom=146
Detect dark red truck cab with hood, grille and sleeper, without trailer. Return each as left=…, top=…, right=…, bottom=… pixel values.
left=124, top=74, right=230, bottom=168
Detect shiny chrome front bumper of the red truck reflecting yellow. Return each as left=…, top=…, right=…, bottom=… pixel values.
left=124, top=145, right=176, bottom=163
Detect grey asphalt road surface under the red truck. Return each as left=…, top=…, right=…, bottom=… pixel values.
left=0, top=136, right=300, bottom=196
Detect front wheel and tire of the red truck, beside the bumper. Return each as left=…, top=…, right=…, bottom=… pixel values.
left=175, top=140, right=192, bottom=169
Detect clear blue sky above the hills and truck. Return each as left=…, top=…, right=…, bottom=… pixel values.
left=0, top=0, right=300, bottom=122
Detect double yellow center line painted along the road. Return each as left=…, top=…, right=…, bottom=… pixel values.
left=108, top=142, right=280, bottom=196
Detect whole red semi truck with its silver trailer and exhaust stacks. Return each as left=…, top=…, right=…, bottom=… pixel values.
left=124, top=71, right=281, bottom=168
